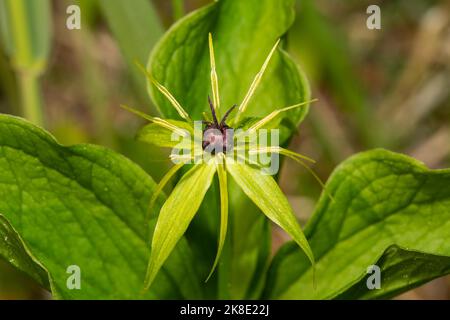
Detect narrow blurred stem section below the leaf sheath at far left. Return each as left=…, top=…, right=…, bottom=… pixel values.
left=17, top=72, right=44, bottom=126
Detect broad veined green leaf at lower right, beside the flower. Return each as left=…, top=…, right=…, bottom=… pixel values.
left=264, top=149, right=450, bottom=299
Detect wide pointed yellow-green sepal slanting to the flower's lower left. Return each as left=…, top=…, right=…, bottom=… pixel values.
left=144, top=164, right=216, bottom=291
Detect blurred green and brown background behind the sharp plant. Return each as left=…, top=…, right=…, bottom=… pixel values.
left=0, top=0, right=450, bottom=299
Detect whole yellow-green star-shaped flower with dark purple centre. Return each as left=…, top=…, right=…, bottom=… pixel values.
left=122, top=34, right=317, bottom=290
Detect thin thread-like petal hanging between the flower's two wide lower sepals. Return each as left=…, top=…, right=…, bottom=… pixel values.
left=205, top=157, right=228, bottom=282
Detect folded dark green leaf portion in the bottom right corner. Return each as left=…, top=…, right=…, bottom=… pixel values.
left=337, top=246, right=450, bottom=299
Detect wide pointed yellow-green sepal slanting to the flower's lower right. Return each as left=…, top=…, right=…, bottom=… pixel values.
left=227, top=162, right=315, bottom=266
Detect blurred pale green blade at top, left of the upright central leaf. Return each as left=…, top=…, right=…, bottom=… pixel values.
left=99, top=0, right=163, bottom=102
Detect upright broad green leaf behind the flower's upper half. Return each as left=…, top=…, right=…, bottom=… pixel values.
left=148, top=0, right=310, bottom=130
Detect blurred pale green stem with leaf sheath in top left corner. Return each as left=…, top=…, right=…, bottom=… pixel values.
left=0, top=0, right=52, bottom=125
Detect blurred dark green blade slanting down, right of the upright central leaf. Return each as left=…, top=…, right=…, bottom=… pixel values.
left=289, top=0, right=377, bottom=152
